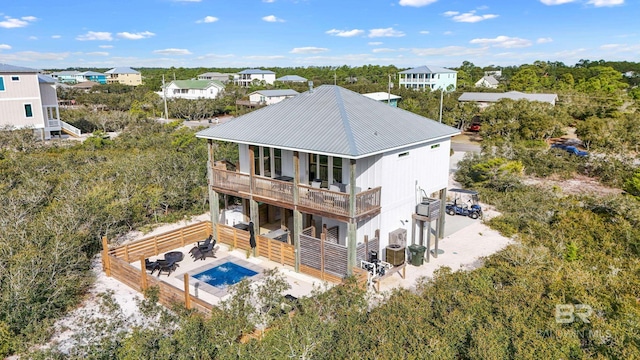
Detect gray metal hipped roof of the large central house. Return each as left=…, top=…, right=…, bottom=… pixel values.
left=196, top=85, right=460, bottom=159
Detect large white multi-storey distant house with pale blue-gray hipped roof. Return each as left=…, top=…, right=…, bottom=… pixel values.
left=399, top=66, right=458, bottom=91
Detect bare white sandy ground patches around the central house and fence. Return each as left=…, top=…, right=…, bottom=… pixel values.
left=43, top=152, right=511, bottom=349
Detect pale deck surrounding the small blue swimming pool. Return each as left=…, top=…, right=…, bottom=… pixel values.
left=131, top=244, right=333, bottom=306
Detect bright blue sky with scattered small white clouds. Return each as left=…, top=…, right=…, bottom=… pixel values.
left=0, top=0, right=640, bottom=68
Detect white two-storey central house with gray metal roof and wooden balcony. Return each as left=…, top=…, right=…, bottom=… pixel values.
left=196, top=85, right=460, bottom=277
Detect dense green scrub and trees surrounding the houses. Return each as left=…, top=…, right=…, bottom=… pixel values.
left=0, top=60, right=640, bottom=359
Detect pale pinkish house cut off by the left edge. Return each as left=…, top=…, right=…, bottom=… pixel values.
left=0, top=64, right=62, bottom=140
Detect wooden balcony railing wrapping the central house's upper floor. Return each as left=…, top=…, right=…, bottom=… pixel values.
left=213, top=169, right=382, bottom=217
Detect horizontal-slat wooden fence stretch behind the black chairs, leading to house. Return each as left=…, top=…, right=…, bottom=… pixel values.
left=109, top=221, right=211, bottom=262
